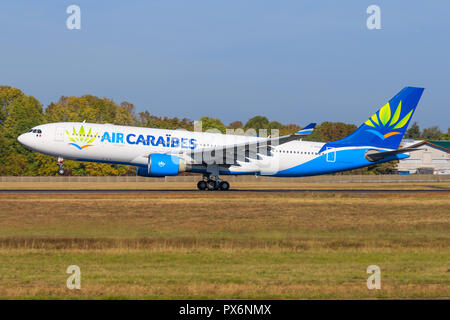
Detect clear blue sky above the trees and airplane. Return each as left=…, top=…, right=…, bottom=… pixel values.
left=0, top=0, right=450, bottom=131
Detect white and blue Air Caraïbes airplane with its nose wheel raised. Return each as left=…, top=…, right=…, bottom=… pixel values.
left=18, top=87, right=424, bottom=191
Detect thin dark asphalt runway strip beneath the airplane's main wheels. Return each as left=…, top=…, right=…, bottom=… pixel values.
left=0, top=187, right=450, bottom=194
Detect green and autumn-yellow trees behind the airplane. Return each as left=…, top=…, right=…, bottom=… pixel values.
left=0, top=86, right=450, bottom=176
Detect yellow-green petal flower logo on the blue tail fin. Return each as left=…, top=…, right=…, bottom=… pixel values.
left=364, top=101, right=414, bottom=140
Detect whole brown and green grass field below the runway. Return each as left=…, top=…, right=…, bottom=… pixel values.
left=0, top=183, right=450, bottom=299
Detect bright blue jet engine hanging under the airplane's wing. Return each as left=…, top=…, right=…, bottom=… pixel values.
left=136, top=153, right=189, bottom=177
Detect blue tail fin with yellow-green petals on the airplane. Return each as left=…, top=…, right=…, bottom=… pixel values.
left=321, top=87, right=424, bottom=151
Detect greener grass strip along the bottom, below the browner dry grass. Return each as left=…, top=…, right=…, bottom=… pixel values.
left=0, top=249, right=450, bottom=299
